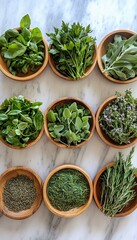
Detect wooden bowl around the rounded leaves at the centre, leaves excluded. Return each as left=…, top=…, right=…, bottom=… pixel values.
left=44, top=97, right=95, bottom=148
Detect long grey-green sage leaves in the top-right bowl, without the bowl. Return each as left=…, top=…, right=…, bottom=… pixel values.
left=102, top=34, right=137, bottom=80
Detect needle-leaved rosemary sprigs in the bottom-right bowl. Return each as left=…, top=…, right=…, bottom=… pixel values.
left=101, top=148, right=137, bottom=217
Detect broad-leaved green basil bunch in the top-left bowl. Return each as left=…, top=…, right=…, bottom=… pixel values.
left=0, top=14, right=44, bottom=75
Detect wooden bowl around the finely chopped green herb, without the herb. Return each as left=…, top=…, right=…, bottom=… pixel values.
left=43, top=164, right=93, bottom=218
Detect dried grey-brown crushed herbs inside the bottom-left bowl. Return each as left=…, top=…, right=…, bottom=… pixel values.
left=3, top=175, right=37, bottom=212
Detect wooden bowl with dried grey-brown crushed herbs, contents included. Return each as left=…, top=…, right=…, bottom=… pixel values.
left=0, top=166, right=43, bottom=220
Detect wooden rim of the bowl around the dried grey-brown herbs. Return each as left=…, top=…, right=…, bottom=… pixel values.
left=0, top=166, right=43, bottom=220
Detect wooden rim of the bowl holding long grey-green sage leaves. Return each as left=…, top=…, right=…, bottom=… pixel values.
left=97, top=29, right=137, bottom=84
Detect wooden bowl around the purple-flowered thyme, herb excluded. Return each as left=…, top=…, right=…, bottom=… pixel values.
left=96, top=96, right=137, bottom=149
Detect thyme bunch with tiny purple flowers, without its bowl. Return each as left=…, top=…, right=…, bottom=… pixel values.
left=99, top=90, right=137, bottom=144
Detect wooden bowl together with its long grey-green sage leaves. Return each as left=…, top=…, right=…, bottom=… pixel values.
left=98, top=30, right=137, bottom=84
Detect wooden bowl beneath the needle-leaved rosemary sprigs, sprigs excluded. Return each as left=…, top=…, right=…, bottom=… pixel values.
left=93, top=162, right=137, bottom=217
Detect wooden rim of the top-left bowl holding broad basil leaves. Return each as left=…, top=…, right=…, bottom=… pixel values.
left=0, top=27, right=49, bottom=82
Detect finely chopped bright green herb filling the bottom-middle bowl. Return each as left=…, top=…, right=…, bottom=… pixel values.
left=47, top=169, right=90, bottom=211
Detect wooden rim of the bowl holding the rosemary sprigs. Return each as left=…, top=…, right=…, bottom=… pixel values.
left=93, top=161, right=137, bottom=217
